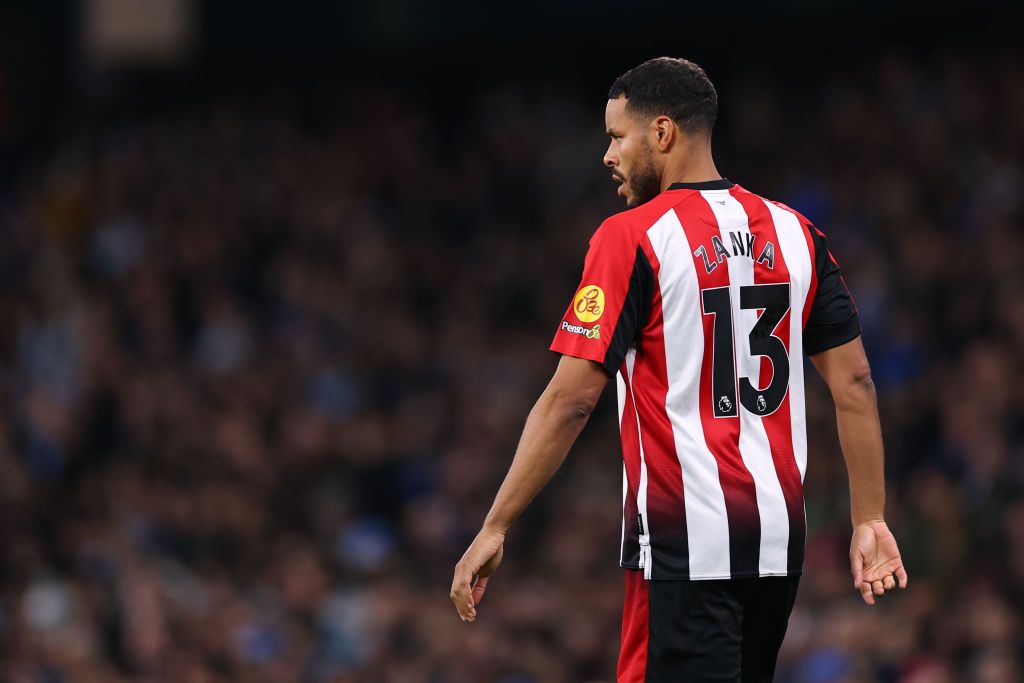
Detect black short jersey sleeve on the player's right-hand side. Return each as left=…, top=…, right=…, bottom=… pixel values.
left=804, top=224, right=860, bottom=355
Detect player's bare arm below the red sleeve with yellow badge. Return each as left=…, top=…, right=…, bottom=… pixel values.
left=451, top=355, right=608, bottom=622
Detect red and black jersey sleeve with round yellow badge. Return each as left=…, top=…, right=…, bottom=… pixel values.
left=550, top=221, right=653, bottom=375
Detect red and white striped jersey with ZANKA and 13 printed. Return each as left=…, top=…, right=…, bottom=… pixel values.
left=551, top=179, right=860, bottom=580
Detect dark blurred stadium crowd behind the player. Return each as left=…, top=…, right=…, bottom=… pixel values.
left=0, top=0, right=1024, bottom=683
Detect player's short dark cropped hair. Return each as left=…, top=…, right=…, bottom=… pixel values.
left=608, top=57, right=718, bottom=134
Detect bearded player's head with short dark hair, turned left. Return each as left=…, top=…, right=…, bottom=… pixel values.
left=604, top=57, right=718, bottom=207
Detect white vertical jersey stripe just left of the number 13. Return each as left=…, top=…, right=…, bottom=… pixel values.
left=647, top=210, right=733, bottom=579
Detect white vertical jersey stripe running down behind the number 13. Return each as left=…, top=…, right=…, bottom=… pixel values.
left=698, top=190, right=791, bottom=575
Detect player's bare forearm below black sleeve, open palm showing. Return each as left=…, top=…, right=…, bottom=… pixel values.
left=811, top=337, right=907, bottom=604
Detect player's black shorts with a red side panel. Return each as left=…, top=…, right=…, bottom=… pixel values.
left=618, top=569, right=800, bottom=683
